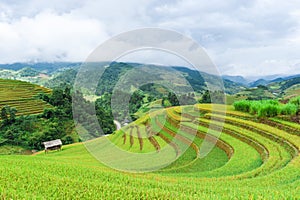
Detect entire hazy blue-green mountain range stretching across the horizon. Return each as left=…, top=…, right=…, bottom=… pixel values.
left=0, top=62, right=300, bottom=98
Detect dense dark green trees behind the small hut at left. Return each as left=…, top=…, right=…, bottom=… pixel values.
left=0, top=87, right=115, bottom=150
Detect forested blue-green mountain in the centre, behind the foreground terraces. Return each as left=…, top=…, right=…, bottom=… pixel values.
left=96, top=62, right=245, bottom=95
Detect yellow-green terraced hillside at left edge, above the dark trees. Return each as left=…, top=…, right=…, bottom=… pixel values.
left=0, top=79, right=51, bottom=115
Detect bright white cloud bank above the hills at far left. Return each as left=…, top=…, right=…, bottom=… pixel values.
left=0, top=11, right=108, bottom=62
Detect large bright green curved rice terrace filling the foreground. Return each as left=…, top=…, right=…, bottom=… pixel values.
left=0, top=104, right=300, bottom=199
